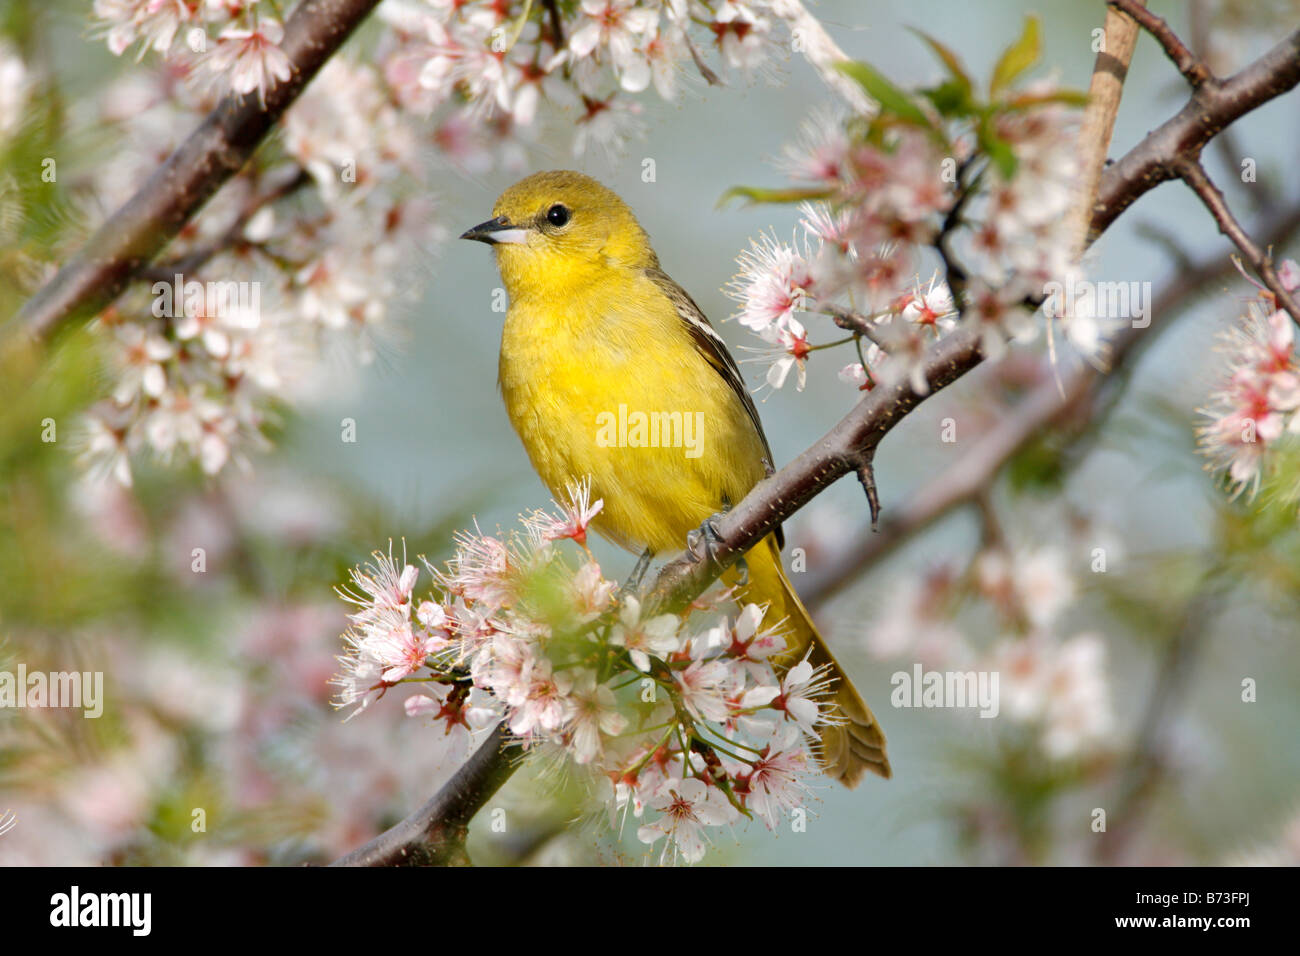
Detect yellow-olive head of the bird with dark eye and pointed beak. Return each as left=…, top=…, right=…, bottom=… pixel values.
left=460, top=170, right=658, bottom=298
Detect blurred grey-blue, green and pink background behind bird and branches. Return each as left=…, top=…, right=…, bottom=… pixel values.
left=0, top=0, right=1300, bottom=865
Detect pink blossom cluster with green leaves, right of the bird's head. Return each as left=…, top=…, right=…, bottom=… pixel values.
left=728, top=31, right=1097, bottom=394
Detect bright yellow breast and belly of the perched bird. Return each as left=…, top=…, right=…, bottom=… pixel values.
left=499, top=268, right=763, bottom=551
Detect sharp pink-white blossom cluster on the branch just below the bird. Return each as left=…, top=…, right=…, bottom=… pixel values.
left=335, top=485, right=836, bottom=862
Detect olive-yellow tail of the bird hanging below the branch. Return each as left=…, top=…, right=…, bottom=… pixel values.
left=732, top=536, right=892, bottom=788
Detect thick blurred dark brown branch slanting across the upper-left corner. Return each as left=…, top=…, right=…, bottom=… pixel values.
left=7, top=0, right=378, bottom=339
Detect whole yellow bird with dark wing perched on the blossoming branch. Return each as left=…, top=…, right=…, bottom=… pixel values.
left=460, top=170, right=889, bottom=787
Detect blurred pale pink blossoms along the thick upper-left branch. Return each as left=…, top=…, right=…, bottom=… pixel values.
left=83, top=57, right=442, bottom=484
